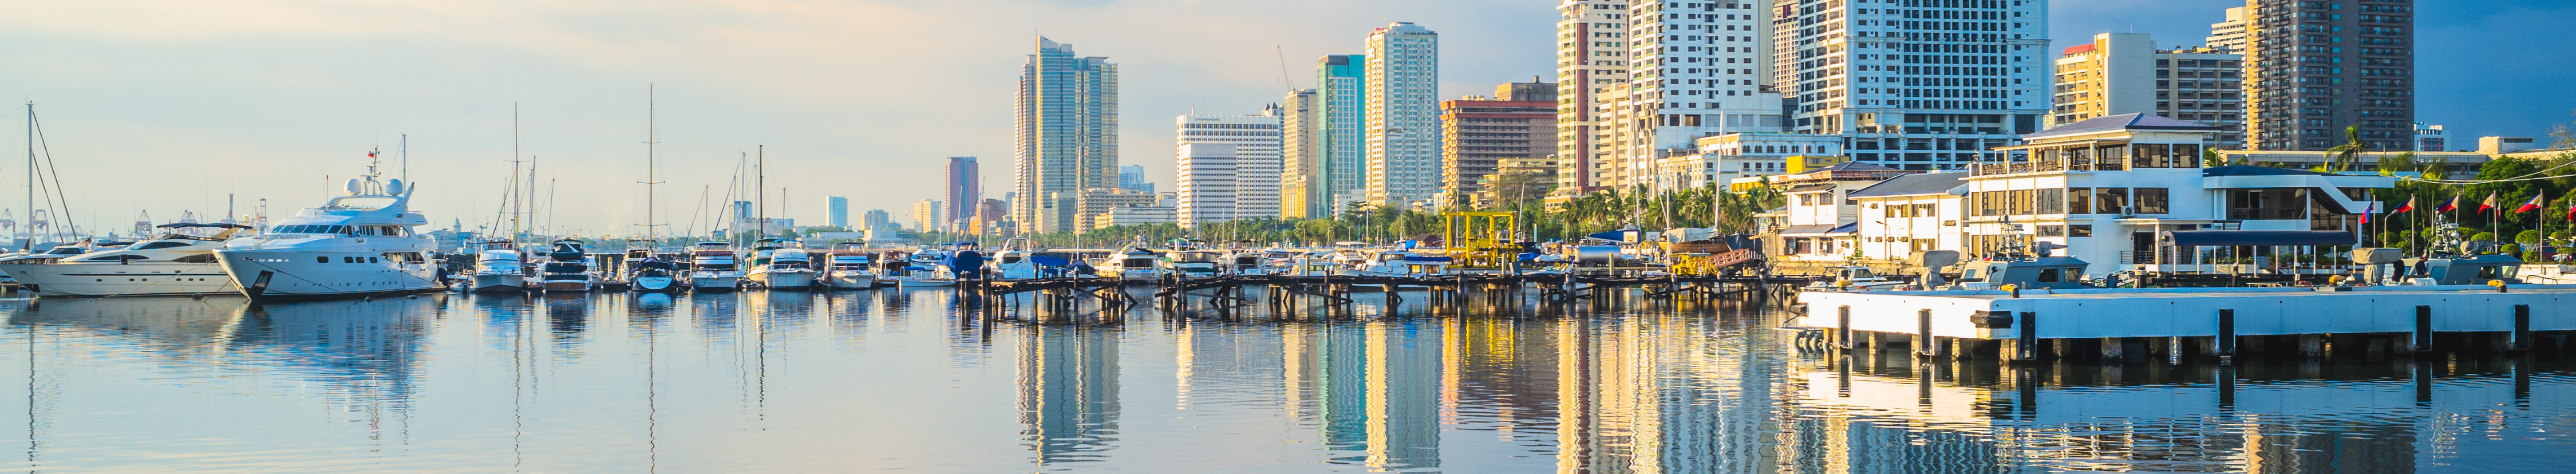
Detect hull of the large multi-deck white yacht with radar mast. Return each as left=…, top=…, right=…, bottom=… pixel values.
left=214, top=250, right=446, bottom=299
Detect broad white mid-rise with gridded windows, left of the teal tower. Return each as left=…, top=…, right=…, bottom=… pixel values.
left=1172, top=106, right=1281, bottom=227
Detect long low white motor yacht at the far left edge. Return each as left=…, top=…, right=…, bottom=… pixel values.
left=0, top=224, right=250, bottom=297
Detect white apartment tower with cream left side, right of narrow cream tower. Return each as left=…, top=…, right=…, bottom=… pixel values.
left=1561, top=0, right=1785, bottom=188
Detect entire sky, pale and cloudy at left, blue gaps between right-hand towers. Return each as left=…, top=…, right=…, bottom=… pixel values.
left=0, top=0, right=2576, bottom=235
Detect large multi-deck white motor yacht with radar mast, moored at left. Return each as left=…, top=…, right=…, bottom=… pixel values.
left=214, top=165, right=441, bottom=299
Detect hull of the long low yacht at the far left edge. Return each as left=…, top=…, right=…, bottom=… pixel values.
left=0, top=263, right=242, bottom=297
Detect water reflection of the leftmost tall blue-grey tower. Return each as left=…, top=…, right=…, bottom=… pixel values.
left=1018, top=325, right=1121, bottom=467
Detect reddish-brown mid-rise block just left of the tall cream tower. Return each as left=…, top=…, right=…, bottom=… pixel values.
left=1435, top=80, right=1556, bottom=209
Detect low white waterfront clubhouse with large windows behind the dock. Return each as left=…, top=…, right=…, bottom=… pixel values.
left=1917, top=113, right=2396, bottom=276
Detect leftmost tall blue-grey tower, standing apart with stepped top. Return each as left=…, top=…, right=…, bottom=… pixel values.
left=1010, top=39, right=1118, bottom=232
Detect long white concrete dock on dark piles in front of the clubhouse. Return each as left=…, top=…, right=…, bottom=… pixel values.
left=1791, top=286, right=2576, bottom=364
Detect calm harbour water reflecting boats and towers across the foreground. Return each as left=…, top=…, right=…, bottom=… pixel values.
left=0, top=291, right=2576, bottom=474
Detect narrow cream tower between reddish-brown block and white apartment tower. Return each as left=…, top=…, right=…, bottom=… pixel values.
left=1556, top=0, right=1628, bottom=196
